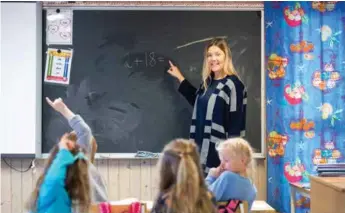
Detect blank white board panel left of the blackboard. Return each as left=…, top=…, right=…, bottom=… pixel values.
left=0, top=2, right=42, bottom=155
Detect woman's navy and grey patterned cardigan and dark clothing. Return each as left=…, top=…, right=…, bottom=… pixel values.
left=178, top=75, right=247, bottom=172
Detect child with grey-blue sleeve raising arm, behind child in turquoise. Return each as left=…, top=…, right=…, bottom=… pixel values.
left=46, top=98, right=108, bottom=203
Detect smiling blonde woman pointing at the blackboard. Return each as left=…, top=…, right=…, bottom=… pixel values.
left=168, top=38, right=245, bottom=173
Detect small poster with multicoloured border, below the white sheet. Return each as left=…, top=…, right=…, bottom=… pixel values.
left=44, top=48, right=73, bottom=85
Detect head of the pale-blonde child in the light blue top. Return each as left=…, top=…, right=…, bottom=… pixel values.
left=217, top=138, right=255, bottom=179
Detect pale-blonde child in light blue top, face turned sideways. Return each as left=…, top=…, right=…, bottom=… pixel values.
left=206, top=138, right=257, bottom=209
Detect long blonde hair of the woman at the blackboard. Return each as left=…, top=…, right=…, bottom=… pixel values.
left=202, top=38, right=238, bottom=91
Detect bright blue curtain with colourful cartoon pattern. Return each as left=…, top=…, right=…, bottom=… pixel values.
left=265, top=1, right=345, bottom=213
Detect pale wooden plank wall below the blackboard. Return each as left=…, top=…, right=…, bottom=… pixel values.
left=1, top=159, right=267, bottom=213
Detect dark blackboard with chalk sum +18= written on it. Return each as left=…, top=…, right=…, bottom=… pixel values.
left=42, top=10, right=262, bottom=153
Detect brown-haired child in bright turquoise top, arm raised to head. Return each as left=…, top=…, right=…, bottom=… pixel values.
left=26, top=133, right=91, bottom=213
